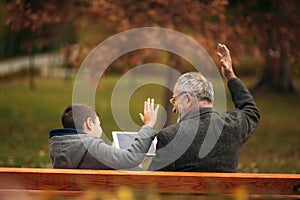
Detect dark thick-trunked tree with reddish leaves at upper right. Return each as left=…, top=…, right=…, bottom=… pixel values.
left=230, top=0, right=300, bottom=93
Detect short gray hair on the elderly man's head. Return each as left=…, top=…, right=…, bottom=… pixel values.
left=176, top=72, right=214, bottom=103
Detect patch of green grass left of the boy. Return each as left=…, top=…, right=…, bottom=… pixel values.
left=0, top=80, right=72, bottom=167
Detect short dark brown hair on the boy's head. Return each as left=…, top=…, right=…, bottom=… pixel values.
left=61, top=104, right=99, bottom=131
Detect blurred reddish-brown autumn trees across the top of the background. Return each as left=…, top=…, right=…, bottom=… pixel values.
left=0, top=0, right=300, bottom=93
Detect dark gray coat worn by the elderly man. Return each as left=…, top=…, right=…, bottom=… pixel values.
left=149, top=79, right=260, bottom=172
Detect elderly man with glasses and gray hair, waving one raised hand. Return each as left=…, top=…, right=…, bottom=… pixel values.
left=148, top=44, right=260, bottom=172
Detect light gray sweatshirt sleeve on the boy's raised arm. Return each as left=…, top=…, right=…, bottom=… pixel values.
left=89, top=126, right=156, bottom=169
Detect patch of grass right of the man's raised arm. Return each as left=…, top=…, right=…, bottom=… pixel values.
left=240, top=79, right=300, bottom=173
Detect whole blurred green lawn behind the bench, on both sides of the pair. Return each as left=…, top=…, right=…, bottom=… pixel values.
left=0, top=76, right=300, bottom=173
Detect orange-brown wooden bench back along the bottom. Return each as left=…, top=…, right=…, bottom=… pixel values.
left=0, top=168, right=300, bottom=200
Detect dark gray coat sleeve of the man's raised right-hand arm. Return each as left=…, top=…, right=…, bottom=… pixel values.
left=227, top=78, right=260, bottom=142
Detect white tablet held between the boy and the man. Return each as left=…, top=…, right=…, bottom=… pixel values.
left=112, top=131, right=157, bottom=157
